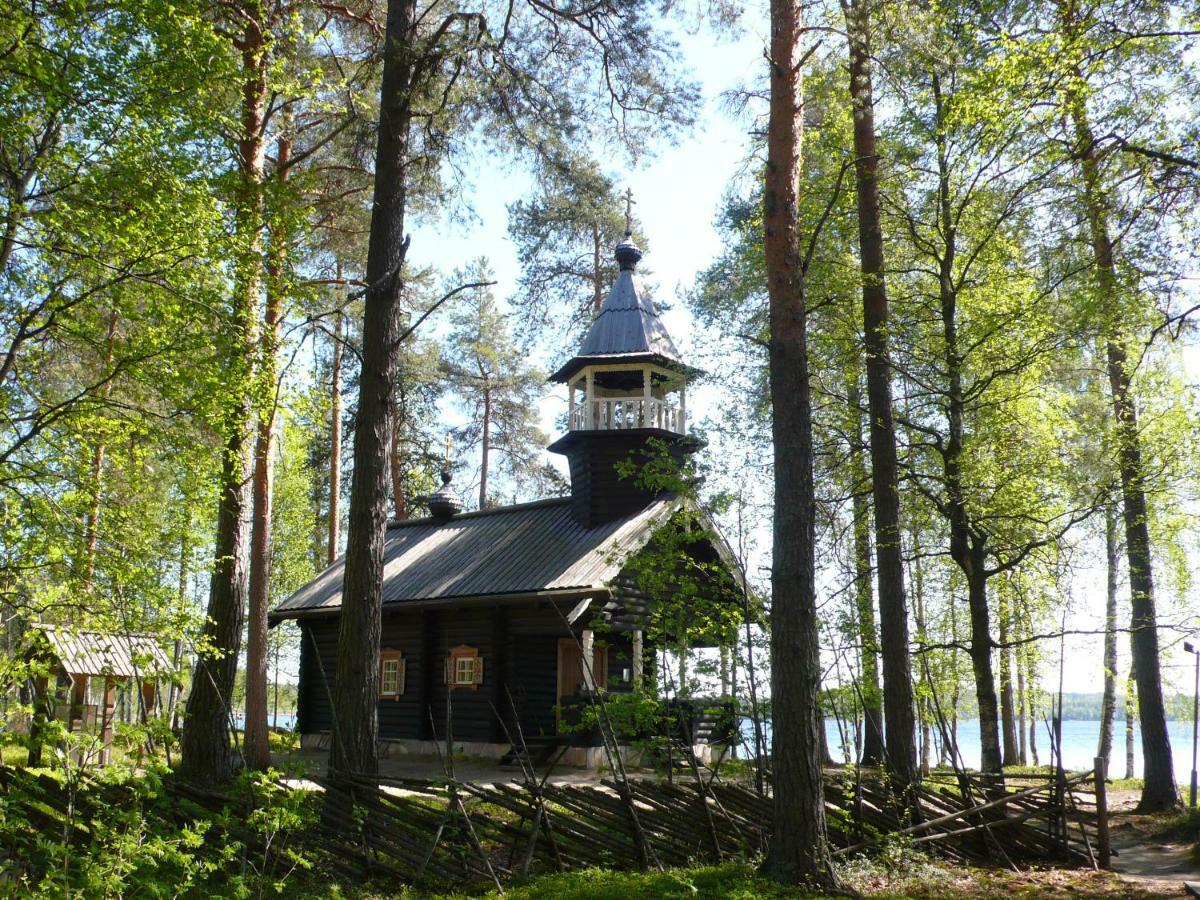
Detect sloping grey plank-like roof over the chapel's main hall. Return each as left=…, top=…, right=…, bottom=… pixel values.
left=271, top=494, right=679, bottom=623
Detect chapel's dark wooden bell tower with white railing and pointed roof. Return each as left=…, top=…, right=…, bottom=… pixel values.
left=550, top=230, right=700, bottom=527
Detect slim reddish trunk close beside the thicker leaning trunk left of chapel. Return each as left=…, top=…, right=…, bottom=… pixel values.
left=244, top=116, right=292, bottom=772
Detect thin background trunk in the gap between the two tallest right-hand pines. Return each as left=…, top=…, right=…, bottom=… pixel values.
left=847, top=372, right=884, bottom=766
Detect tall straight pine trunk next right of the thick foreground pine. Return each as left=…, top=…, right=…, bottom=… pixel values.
left=844, top=0, right=918, bottom=806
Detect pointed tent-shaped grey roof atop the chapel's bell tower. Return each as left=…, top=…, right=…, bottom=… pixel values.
left=551, top=254, right=696, bottom=382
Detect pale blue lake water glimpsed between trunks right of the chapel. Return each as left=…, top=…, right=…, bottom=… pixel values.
left=742, top=719, right=1192, bottom=786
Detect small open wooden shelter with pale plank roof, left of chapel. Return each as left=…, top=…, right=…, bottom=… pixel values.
left=29, top=624, right=175, bottom=764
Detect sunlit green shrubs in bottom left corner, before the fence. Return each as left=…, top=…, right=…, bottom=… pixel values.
left=0, top=766, right=319, bottom=898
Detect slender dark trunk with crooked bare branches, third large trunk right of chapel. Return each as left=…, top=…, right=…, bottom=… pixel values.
left=931, top=73, right=1003, bottom=775
